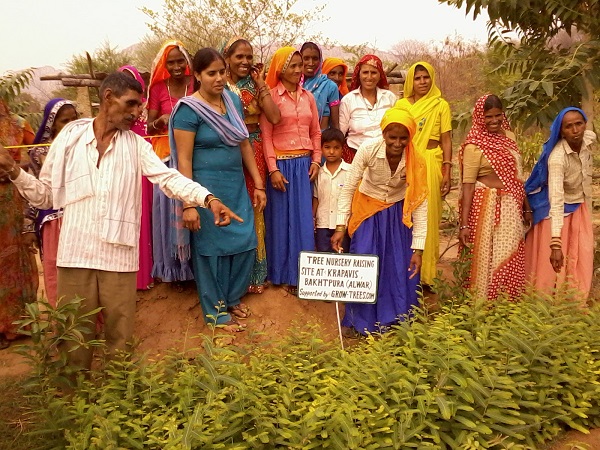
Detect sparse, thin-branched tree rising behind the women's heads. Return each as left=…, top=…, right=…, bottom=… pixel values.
left=142, top=0, right=324, bottom=61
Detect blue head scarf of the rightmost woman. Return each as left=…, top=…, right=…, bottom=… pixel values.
left=525, top=106, right=587, bottom=225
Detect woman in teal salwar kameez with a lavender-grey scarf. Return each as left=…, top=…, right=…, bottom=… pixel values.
left=169, top=49, right=266, bottom=331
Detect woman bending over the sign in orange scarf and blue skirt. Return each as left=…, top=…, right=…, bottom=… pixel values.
left=331, top=108, right=428, bottom=334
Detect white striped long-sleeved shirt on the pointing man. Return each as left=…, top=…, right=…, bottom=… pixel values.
left=13, top=122, right=210, bottom=272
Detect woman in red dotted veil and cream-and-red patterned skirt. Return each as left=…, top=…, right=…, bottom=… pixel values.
left=459, top=95, right=531, bottom=300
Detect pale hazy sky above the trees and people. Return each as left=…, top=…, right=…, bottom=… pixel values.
left=0, top=0, right=487, bottom=74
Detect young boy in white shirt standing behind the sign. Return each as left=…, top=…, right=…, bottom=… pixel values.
left=313, top=128, right=350, bottom=252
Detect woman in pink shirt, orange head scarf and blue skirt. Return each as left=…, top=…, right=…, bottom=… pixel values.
left=260, top=47, right=321, bottom=293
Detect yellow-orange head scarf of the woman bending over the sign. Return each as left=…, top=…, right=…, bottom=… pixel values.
left=380, top=107, right=429, bottom=227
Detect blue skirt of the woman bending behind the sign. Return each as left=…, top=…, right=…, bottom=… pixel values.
left=342, top=201, right=420, bottom=334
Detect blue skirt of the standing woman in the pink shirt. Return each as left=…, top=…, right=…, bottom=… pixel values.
left=265, top=156, right=315, bottom=286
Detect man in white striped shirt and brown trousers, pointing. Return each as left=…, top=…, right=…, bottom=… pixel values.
left=0, top=73, right=241, bottom=369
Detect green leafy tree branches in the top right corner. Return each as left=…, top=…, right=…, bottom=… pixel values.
left=439, top=0, right=600, bottom=127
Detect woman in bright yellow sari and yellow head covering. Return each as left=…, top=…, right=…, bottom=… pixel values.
left=396, top=61, right=452, bottom=285
